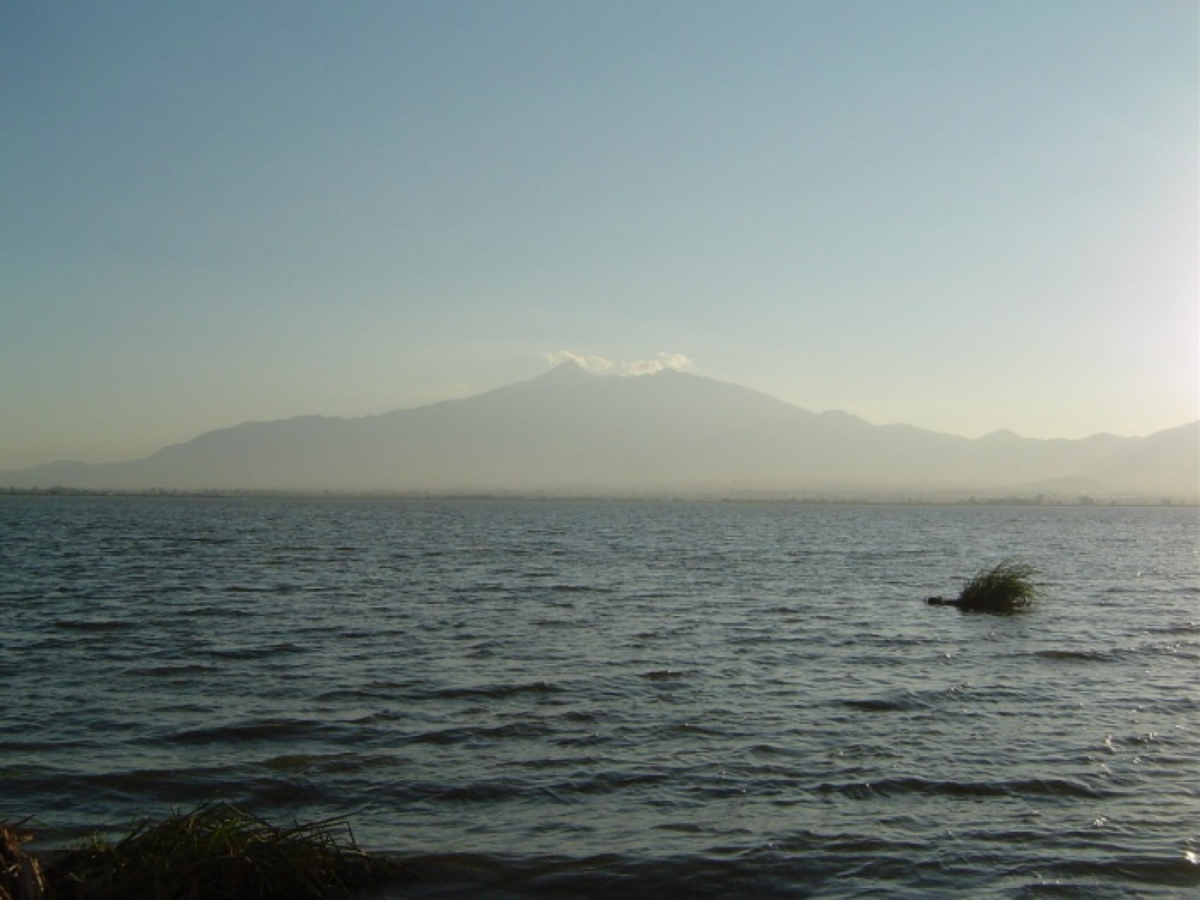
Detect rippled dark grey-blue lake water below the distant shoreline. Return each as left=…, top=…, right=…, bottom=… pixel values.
left=0, top=497, right=1200, bottom=900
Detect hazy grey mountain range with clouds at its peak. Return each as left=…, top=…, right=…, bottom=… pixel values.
left=7, top=364, right=1200, bottom=502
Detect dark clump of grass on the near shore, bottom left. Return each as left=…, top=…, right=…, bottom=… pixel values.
left=47, top=803, right=400, bottom=900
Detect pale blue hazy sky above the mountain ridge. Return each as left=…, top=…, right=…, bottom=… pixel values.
left=0, top=0, right=1200, bottom=469
